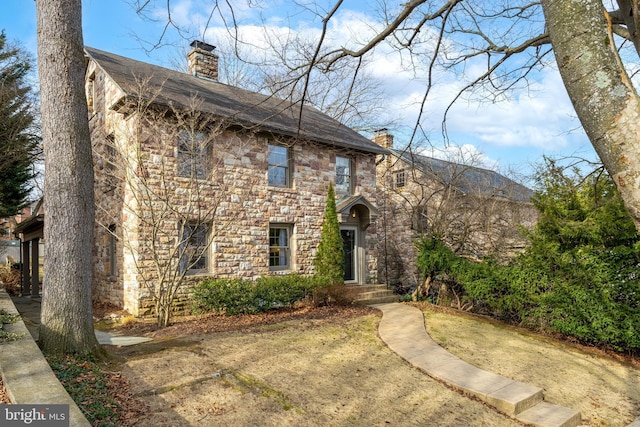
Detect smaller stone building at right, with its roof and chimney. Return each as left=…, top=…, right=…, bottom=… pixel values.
left=374, top=130, right=537, bottom=290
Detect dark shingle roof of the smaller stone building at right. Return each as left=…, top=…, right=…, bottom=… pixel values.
left=391, top=150, right=533, bottom=202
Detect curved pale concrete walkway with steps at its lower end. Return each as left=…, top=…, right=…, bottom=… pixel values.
left=372, top=303, right=581, bottom=427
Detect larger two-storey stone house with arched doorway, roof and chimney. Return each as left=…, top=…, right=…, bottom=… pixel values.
left=85, top=42, right=387, bottom=315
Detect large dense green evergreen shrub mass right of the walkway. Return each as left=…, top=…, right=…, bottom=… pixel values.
left=417, top=161, right=640, bottom=354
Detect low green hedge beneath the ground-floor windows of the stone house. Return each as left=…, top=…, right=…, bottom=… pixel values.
left=193, top=274, right=326, bottom=316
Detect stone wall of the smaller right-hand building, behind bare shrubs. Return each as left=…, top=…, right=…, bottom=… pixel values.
left=377, top=142, right=537, bottom=290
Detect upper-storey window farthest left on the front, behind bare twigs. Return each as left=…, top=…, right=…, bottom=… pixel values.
left=177, top=130, right=210, bottom=179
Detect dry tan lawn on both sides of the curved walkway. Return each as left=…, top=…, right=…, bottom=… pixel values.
left=102, top=306, right=640, bottom=426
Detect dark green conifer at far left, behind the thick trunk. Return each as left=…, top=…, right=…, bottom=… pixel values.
left=0, top=31, right=39, bottom=217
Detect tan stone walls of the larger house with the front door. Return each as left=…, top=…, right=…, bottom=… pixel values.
left=87, top=58, right=378, bottom=315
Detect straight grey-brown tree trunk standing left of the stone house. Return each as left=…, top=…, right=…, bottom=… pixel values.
left=36, top=0, right=100, bottom=353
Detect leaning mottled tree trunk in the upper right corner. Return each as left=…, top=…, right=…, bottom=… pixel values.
left=542, top=0, right=640, bottom=231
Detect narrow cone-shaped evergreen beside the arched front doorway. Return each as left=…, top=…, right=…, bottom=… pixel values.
left=314, top=183, right=344, bottom=285
